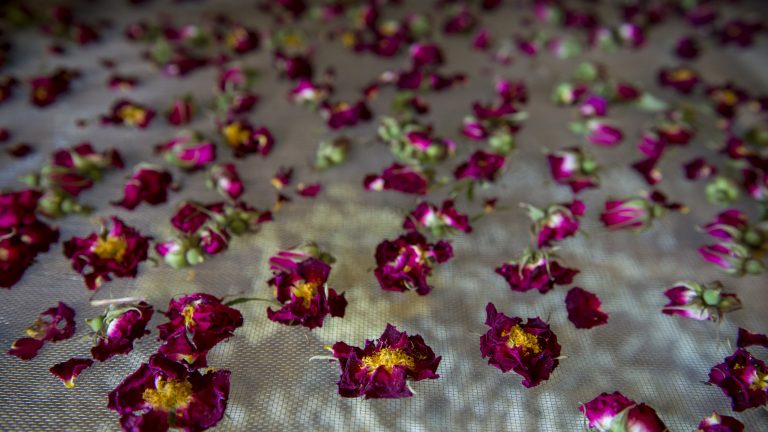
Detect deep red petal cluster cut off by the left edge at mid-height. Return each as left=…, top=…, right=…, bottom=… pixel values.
left=0, top=189, right=59, bottom=288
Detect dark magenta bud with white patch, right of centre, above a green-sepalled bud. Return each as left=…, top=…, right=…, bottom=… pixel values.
left=547, top=147, right=599, bottom=194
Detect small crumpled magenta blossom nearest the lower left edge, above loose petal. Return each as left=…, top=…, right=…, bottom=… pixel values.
left=8, top=302, right=75, bottom=360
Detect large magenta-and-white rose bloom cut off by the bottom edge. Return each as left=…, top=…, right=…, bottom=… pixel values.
left=579, top=392, right=669, bottom=432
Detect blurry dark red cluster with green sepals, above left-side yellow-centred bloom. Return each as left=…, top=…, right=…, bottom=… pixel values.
left=23, top=142, right=123, bottom=218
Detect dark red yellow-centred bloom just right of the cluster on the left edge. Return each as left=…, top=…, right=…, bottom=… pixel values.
left=64, top=216, right=151, bottom=290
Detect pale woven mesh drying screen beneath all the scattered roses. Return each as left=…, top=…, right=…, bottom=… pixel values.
left=0, top=0, right=768, bottom=432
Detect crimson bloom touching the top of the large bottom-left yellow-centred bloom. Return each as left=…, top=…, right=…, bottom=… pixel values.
left=157, top=293, right=243, bottom=368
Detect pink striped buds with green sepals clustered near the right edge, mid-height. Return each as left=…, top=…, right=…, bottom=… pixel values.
left=699, top=209, right=768, bottom=276
